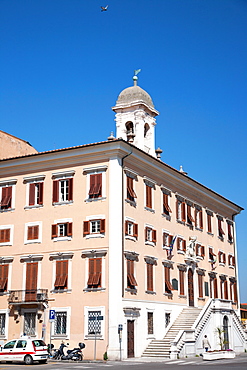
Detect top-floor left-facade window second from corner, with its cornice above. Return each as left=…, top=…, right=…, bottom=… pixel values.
left=52, top=171, right=75, bottom=204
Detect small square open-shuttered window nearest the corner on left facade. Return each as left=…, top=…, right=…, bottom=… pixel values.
left=83, top=215, right=106, bottom=238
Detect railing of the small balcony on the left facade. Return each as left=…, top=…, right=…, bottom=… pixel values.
left=8, top=289, right=48, bottom=304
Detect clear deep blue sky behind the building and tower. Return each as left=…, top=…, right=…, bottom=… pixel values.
left=0, top=0, right=247, bottom=302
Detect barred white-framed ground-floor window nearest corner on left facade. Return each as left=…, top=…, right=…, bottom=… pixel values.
left=84, top=306, right=105, bottom=339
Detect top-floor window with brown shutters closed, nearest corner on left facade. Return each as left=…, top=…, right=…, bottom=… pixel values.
left=83, top=165, right=107, bottom=201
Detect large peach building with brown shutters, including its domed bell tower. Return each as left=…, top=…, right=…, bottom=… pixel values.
left=0, top=80, right=246, bottom=359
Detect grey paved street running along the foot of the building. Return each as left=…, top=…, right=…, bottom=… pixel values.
left=0, top=354, right=247, bottom=370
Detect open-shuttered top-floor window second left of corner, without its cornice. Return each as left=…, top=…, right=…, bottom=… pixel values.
left=52, top=178, right=73, bottom=203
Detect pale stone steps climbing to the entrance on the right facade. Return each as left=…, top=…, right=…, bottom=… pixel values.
left=142, top=307, right=201, bottom=358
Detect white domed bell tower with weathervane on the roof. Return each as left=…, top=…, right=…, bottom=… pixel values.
left=112, top=70, right=159, bottom=157
